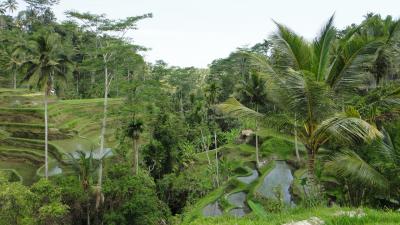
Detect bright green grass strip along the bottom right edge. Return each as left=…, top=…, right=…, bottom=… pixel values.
left=190, top=207, right=400, bottom=225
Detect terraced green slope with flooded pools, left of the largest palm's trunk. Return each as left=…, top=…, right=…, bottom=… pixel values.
left=184, top=130, right=305, bottom=224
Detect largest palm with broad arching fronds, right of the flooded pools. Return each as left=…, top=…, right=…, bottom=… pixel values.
left=219, top=16, right=382, bottom=185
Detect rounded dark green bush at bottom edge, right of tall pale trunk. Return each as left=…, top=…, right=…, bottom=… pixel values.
left=103, top=164, right=169, bottom=225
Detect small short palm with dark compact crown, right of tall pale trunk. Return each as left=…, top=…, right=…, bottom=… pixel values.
left=126, top=119, right=143, bottom=175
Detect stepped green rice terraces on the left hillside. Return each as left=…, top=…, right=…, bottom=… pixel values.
left=0, top=89, right=121, bottom=184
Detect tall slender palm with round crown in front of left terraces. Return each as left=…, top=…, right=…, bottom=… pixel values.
left=22, top=32, right=71, bottom=179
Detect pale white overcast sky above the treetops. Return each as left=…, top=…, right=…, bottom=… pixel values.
left=14, top=0, right=400, bottom=67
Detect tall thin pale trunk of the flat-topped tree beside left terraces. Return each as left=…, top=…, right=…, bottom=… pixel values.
left=96, top=62, right=108, bottom=208
